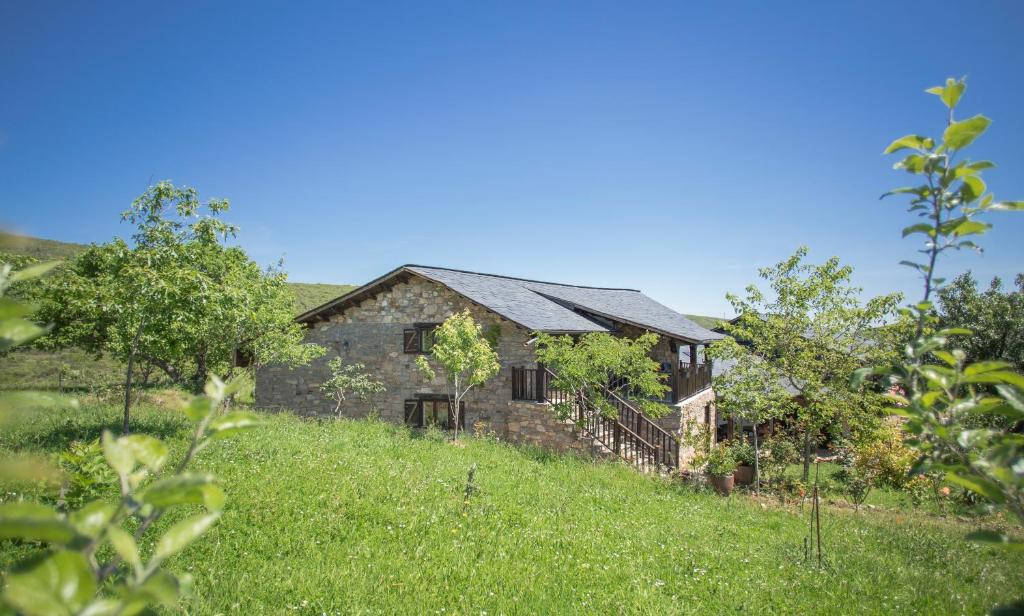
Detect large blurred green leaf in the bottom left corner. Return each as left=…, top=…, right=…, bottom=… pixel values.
left=3, top=552, right=96, bottom=616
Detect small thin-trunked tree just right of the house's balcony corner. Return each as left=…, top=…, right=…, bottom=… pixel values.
left=709, top=338, right=797, bottom=494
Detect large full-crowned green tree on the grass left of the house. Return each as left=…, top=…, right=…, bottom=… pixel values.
left=39, top=182, right=324, bottom=432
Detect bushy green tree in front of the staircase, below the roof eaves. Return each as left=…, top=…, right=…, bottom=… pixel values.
left=537, top=332, right=670, bottom=417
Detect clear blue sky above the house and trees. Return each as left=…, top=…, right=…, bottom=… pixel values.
left=0, top=1, right=1024, bottom=315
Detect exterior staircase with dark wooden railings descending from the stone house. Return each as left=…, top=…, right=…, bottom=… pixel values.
left=512, top=367, right=679, bottom=472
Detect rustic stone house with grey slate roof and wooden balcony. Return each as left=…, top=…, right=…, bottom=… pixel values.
left=256, top=265, right=722, bottom=467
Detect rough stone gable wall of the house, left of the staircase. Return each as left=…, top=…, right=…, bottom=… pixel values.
left=256, top=276, right=606, bottom=452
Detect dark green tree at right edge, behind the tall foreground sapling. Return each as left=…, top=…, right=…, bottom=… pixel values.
left=938, top=271, right=1024, bottom=371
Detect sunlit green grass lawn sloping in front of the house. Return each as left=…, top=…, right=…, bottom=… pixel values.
left=0, top=394, right=1024, bottom=614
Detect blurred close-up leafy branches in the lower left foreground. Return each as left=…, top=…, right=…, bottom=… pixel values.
left=0, top=263, right=259, bottom=616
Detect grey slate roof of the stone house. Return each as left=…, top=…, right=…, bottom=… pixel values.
left=299, top=265, right=723, bottom=343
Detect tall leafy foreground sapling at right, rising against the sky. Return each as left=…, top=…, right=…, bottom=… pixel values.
left=851, top=79, right=1024, bottom=547
